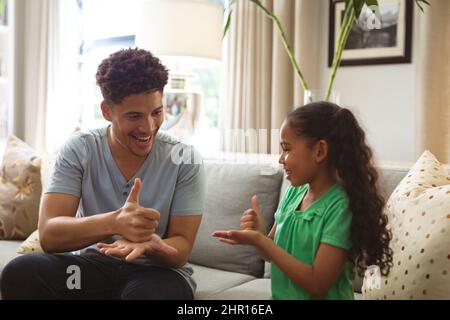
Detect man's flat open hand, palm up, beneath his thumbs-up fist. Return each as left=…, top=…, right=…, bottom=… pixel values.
left=97, top=233, right=178, bottom=261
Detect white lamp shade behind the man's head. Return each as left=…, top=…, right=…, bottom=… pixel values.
left=136, top=0, right=223, bottom=60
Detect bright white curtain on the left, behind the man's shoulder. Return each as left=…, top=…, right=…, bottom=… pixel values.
left=14, top=0, right=80, bottom=151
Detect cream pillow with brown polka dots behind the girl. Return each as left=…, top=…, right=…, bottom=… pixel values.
left=362, top=151, right=450, bottom=299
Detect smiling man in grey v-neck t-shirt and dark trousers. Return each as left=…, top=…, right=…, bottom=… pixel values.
left=1, top=49, right=204, bottom=299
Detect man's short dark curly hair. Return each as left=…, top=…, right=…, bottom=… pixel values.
left=95, top=48, right=168, bottom=103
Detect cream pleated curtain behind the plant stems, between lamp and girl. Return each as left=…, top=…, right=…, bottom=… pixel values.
left=220, top=0, right=320, bottom=153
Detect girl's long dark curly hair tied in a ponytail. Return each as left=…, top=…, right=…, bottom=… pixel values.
left=287, top=102, right=393, bottom=276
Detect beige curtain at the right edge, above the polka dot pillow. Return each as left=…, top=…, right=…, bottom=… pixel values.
left=417, top=0, right=450, bottom=163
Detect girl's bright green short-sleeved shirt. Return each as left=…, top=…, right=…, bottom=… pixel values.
left=272, top=184, right=353, bottom=300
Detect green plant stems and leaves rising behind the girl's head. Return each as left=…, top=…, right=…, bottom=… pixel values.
left=223, top=0, right=430, bottom=100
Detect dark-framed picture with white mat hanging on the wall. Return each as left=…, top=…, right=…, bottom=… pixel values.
left=328, top=0, right=413, bottom=66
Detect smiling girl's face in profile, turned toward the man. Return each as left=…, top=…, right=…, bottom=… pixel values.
left=278, top=121, right=318, bottom=187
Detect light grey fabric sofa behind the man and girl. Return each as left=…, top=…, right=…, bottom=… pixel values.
left=0, top=149, right=426, bottom=300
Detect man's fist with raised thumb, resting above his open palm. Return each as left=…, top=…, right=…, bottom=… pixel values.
left=115, top=178, right=160, bottom=242
